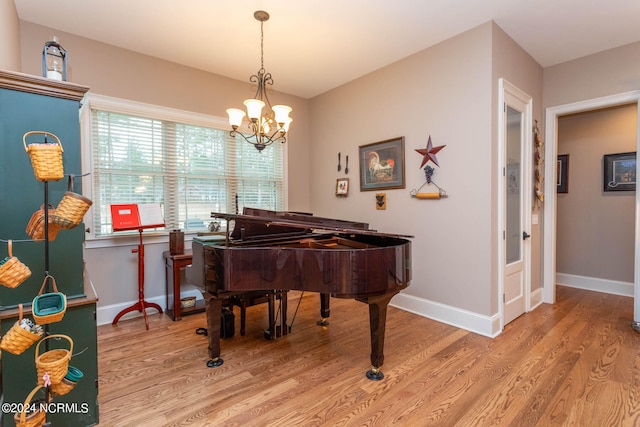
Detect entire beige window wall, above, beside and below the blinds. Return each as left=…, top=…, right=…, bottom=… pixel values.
left=20, top=21, right=310, bottom=312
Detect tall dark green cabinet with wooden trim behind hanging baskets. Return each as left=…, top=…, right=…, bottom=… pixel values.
left=0, top=70, right=98, bottom=427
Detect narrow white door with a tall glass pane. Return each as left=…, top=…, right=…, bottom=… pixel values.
left=501, top=81, right=533, bottom=325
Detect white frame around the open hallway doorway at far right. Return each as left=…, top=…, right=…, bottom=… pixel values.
left=542, top=91, right=640, bottom=322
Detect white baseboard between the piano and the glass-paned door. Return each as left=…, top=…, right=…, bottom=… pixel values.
left=390, top=292, right=501, bottom=338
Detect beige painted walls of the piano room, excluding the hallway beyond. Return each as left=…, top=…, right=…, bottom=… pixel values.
left=15, top=13, right=640, bottom=330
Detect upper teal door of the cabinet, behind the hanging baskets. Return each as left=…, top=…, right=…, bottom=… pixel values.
left=0, top=89, right=84, bottom=310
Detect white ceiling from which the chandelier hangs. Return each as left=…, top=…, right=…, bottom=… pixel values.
left=14, top=0, right=640, bottom=98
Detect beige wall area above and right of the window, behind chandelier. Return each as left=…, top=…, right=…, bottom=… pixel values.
left=20, top=21, right=309, bottom=210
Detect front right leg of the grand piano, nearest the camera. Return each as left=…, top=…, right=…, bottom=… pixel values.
left=356, top=292, right=398, bottom=381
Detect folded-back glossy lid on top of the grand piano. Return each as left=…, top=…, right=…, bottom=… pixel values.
left=211, top=208, right=413, bottom=240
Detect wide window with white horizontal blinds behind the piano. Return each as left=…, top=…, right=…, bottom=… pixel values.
left=83, top=95, right=284, bottom=237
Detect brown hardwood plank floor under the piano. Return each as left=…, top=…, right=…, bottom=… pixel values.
left=98, top=286, right=640, bottom=427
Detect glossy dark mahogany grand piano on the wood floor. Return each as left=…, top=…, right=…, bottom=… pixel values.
left=189, top=208, right=412, bottom=380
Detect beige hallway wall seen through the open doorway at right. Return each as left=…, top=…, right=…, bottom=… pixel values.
left=556, top=104, right=638, bottom=283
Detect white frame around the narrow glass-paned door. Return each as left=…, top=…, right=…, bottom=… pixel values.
left=497, top=78, right=533, bottom=331
